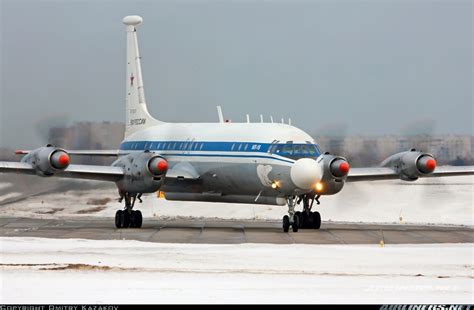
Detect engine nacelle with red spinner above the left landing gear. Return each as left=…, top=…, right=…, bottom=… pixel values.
left=112, top=151, right=168, bottom=194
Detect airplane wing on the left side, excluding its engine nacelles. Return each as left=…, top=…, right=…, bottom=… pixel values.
left=0, top=162, right=124, bottom=182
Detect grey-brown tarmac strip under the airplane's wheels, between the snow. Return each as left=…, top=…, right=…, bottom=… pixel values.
left=0, top=217, right=474, bottom=245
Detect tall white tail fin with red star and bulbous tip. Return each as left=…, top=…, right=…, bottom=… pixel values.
left=122, top=15, right=161, bottom=139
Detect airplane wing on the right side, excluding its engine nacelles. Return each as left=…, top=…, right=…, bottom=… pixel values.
left=347, top=166, right=474, bottom=182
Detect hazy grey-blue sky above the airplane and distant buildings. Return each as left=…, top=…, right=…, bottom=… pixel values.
left=0, top=0, right=473, bottom=148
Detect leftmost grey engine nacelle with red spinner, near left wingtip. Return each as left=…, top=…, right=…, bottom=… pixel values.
left=21, top=144, right=71, bottom=176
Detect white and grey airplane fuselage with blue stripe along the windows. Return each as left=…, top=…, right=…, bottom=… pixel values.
left=120, top=123, right=320, bottom=204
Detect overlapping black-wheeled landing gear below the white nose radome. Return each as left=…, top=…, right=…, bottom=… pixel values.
left=283, top=194, right=321, bottom=232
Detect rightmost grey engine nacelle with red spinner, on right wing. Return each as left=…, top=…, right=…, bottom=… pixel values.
left=381, top=149, right=436, bottom=181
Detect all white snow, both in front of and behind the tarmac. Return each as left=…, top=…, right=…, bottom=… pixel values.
left=0, top=177, right=474, bottom=304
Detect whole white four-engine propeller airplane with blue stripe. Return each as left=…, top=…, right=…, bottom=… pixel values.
left=0, top=15, right=474, bottom=232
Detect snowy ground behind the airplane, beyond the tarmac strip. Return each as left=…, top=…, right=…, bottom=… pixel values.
left=0, top=176, right=474, bottom=226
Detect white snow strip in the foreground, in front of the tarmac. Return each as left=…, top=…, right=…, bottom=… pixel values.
left=0, top=238, right=474, bottom=304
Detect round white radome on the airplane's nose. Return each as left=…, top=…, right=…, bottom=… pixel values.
left=290, top=158, right=321, bottom=190
